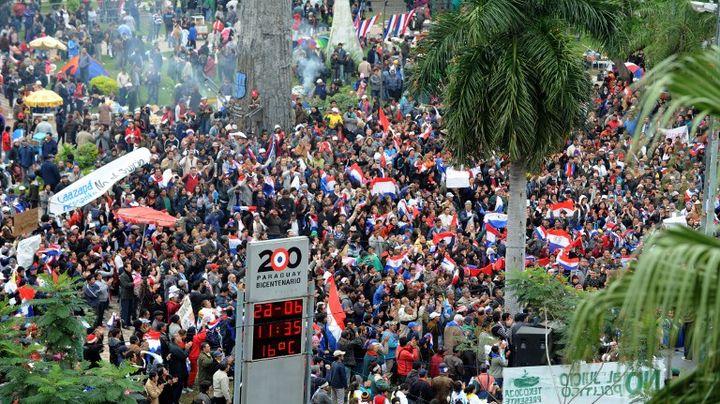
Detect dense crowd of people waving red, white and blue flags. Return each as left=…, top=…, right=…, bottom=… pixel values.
left=0, top=0, right=718, bottom=404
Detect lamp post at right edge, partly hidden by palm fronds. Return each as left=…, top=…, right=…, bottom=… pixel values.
left=690, top=1, right=720, bottom=237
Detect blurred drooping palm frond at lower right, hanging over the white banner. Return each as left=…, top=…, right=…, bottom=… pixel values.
left=568, top=227, right=720, bottom=402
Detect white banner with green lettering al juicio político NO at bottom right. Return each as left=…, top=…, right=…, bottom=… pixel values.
left=503, top=362, right=665, bottom=404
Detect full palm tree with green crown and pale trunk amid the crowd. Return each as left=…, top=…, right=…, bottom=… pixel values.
left=411, top=0, right=618, bottom=310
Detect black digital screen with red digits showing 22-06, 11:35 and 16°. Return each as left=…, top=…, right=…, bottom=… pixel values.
left=252, top=299, right=303, bottom=360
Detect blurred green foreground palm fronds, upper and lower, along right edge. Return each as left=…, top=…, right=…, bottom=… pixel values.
left=568, top=48, right=720, bottom=403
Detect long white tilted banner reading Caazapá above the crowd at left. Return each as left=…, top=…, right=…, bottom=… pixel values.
left=48, top=147, right=150, bottom=215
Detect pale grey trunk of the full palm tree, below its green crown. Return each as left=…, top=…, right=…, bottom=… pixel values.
left=505, top=161, right=527, bottom=314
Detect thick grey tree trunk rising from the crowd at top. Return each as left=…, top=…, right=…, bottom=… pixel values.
left=235, top=0, right=292, bottom=130
